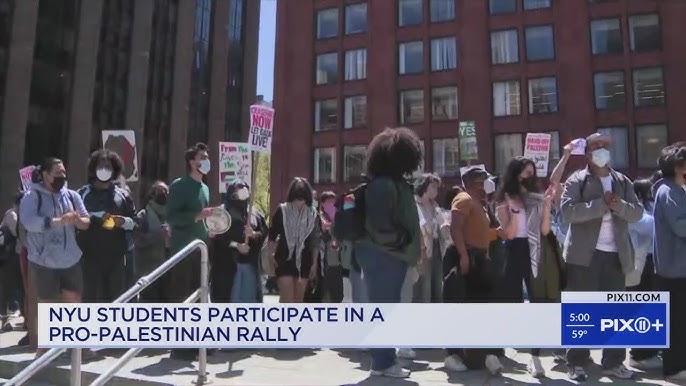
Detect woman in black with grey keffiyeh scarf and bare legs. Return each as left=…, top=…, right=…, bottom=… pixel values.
left=269, top=177, right=321, bottom=303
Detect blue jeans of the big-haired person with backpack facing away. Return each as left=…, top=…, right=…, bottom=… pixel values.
left=355, top=245, right=407, bottom=371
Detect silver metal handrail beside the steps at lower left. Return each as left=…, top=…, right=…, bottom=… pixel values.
left=4, top=240, right=210, bottom=386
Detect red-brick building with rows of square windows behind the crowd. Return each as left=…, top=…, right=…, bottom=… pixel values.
left=271, top=0, right=686, bottom=208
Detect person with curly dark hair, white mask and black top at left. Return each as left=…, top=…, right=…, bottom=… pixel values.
left=77, top=149, right=138, bottom=303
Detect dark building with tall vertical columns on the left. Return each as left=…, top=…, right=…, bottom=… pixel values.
left=0, top=0, right=260, bottom=207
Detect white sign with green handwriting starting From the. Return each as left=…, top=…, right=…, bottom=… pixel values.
left=219, top=142, right=252, bottom=193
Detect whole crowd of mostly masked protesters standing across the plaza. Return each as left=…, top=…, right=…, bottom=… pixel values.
left=0, top=128, right=686, bottom=381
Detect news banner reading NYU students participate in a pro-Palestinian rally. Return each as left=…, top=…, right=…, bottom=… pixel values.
left=38, top=292, right=669, bottom=348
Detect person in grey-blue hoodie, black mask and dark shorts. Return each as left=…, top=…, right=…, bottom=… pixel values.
left=19, top=158, right=90, bottom=356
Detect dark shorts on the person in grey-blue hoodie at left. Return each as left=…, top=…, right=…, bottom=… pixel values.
left=29, top=261, right=83, bottom=300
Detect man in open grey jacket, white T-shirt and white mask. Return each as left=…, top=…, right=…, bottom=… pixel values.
left=560, top=133, right=643, bottom=381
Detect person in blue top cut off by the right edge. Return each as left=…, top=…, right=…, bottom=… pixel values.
left=653, top=142, right=686, bottom=381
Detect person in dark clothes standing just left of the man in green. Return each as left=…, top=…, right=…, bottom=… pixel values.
left=133, top=181, right=171, bottom=303
